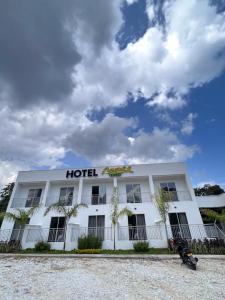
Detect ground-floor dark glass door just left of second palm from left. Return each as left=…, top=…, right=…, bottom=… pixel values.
left=48, top=217, right=65, bottom=242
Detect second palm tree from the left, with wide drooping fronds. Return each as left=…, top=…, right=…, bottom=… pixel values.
left=44, top=201, right=87, bottom=250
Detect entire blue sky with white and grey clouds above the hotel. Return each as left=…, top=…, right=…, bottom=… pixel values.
left=0, top=0, right=225, bottom=185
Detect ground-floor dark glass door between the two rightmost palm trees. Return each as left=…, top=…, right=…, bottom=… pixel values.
left=128, top=214, right=147, bottom=240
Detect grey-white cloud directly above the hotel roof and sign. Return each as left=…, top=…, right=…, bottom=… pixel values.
left=66, top=114, right=198, bottom=165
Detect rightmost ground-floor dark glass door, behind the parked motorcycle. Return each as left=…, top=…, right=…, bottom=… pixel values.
left=169, top=213, right=191, bottom=239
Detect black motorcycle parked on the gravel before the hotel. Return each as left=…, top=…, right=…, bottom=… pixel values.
left=173, top=239, right=198, bottom=270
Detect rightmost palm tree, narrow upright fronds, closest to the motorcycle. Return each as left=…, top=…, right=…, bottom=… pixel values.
left=155, top=189, right=171, bottom=245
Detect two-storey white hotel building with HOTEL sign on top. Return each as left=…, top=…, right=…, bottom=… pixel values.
left=0, top=163, right=225, bottom=250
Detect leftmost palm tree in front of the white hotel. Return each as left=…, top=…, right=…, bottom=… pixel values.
left=0, top=206, right=39, bottom=239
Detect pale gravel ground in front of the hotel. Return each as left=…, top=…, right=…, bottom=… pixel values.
left=0, top=257, right=225, bottom=300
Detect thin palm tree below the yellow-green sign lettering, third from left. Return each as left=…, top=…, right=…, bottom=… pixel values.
left=111, top=187, right=133, bottom=250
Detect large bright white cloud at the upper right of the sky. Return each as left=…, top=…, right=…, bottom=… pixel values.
left=73, top=0, right=225, bottom=109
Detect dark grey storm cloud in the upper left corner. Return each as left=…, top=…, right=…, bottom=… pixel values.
left=0, top=0, right=121, bottom=106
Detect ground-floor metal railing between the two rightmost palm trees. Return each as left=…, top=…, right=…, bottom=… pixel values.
left=118, top=225, right=162, bottom=241
